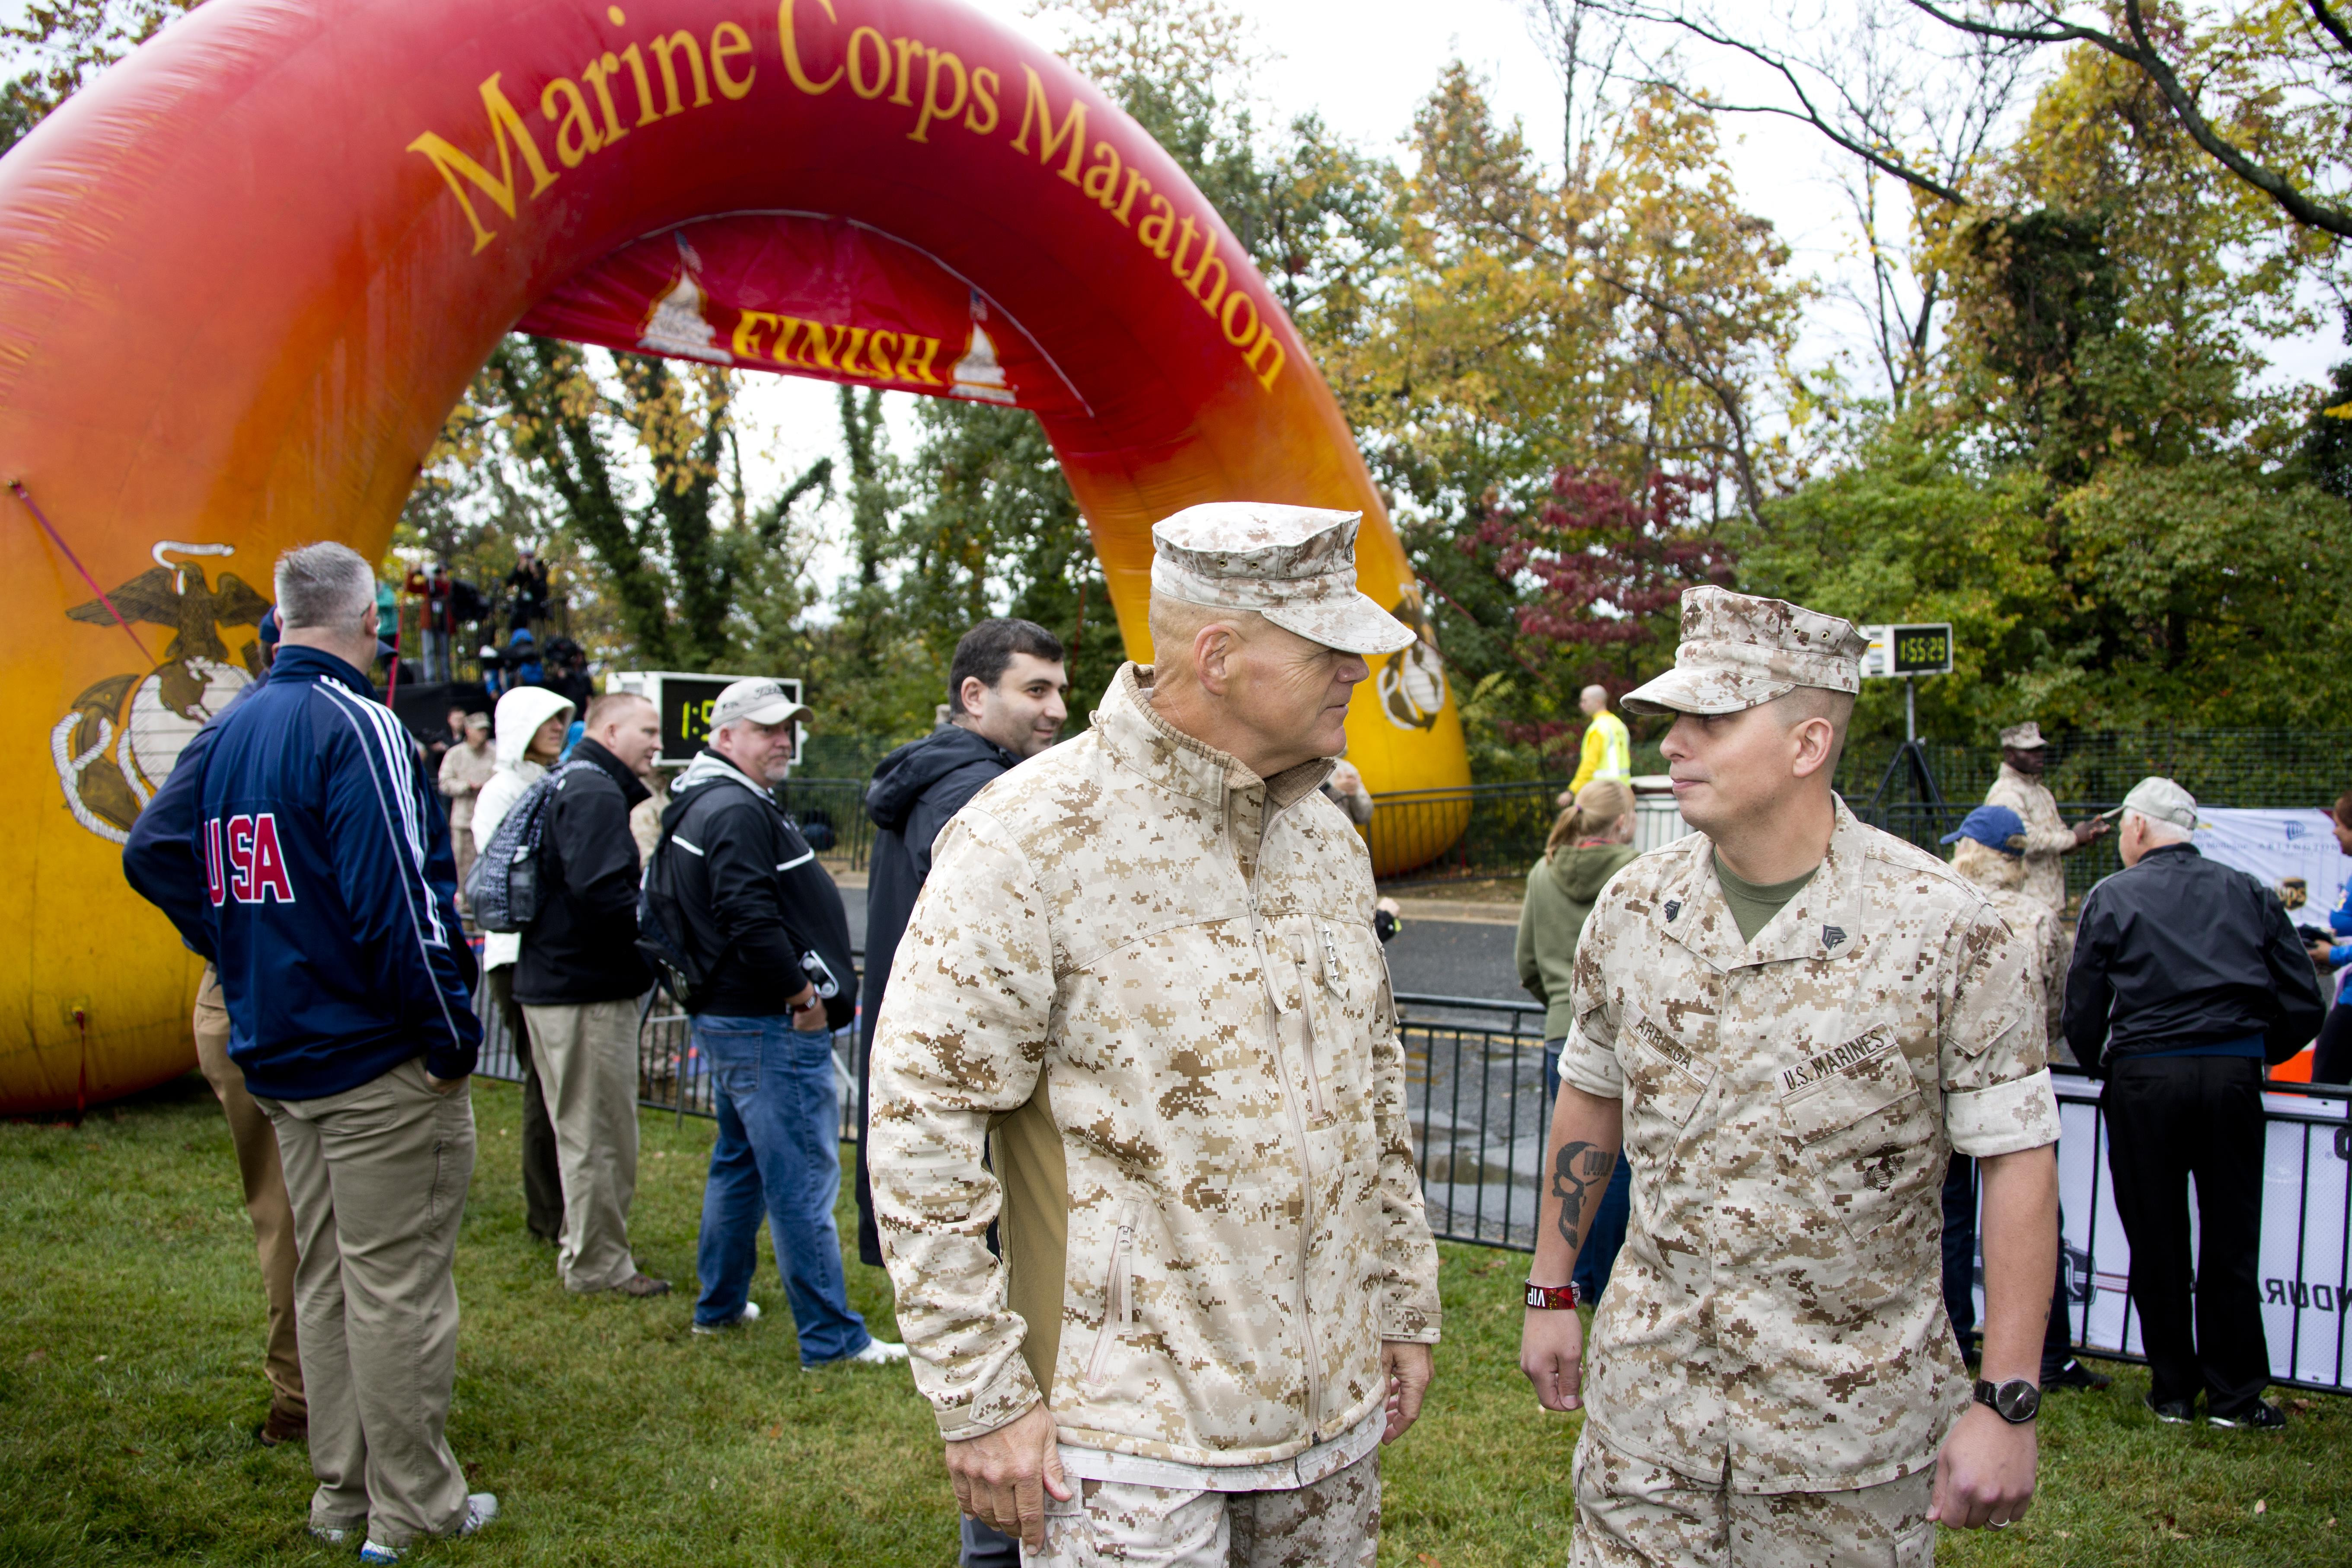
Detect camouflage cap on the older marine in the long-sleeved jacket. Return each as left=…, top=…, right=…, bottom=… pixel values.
left=1152, top=501, right=1414, bottom=654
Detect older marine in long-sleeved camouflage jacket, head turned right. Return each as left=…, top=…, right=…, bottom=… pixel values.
left=868, top=505, right=1439, bottom=1568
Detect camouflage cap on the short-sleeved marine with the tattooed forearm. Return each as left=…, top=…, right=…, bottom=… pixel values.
left=1618, top=588, right=1870, bottom=712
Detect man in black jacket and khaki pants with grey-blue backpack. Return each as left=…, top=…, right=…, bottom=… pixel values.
left=515, top=691, right=670, bottom=1298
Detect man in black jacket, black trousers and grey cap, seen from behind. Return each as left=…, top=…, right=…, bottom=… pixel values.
left=2065, top=778, right=2324, bottom=1429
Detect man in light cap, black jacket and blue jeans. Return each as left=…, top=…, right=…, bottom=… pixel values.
left=668, top=680, right=906, bottom=1370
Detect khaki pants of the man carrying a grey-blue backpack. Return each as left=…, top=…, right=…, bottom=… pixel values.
left=522, top=1001, right=638, bottom=1290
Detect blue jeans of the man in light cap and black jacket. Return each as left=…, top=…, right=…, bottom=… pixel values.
left=694, top=1013, right=873, bottom=1366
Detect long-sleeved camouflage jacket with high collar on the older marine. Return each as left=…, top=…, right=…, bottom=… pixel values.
left=868, top=665, right=1437, bottom=1467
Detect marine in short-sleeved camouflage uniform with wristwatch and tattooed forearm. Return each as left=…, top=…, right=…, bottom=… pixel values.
left=1519, top=588, right=2058, bottom=1568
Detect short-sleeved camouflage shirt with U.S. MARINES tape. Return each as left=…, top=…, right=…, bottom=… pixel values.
left=1559, top=802, right=2058, bottom=1493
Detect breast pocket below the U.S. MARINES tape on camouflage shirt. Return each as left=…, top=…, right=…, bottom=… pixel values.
left=1781, top=1027, right=1936, bottom=1236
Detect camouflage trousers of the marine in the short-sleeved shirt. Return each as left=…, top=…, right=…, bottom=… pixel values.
left=1569, top=1432, right=1936, bottom=1568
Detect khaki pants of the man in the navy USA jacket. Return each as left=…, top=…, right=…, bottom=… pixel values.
left=256, top=1056, right=473, bottom=1547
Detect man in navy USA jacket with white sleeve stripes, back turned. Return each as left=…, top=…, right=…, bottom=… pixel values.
left=195, top=543, right=498, bottom=1563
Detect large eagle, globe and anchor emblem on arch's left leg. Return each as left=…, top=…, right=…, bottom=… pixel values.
left=49, top=538, right=271, bottom=844
